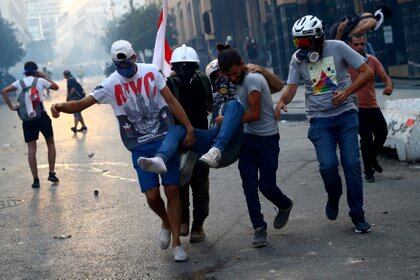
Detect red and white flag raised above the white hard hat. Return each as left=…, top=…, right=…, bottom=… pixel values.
left=152, top=0, right=172, bottom=77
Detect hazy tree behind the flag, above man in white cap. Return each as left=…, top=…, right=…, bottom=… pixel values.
left=104, top=4, right=178, bottom=62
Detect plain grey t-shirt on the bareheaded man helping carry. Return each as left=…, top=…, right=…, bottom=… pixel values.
left=237, top=73, right=279, bottom=136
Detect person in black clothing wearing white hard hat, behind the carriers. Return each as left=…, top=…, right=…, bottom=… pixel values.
left=167, top=44, right=213, bottom=242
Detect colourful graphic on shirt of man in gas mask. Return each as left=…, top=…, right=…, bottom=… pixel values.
left=308, top=56, right=338, bottom=95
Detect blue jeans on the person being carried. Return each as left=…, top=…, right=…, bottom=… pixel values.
left=156, top=100, right=244, bottom=163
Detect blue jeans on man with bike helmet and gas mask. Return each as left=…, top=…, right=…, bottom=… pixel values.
left=308, top=110, right=364, bottom=217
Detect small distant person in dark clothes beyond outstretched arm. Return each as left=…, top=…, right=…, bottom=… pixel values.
left=63, top=70, right=87, bottom=133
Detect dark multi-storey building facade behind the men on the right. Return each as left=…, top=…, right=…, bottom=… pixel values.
left=169, top=0, right=420, bottom=79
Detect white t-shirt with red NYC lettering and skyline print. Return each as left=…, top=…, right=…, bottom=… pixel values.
left=90, top=63, right=173, bottom=150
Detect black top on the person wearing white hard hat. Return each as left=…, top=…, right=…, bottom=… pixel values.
left=167, top=74, right=212, bottom=129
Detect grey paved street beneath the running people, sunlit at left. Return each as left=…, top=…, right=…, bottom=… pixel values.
left=0, top=77, right=420, bottom=279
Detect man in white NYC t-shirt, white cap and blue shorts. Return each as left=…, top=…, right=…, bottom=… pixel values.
left=51, top=40, right=195, bottom=261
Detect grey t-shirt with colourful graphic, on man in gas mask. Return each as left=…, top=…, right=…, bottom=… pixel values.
left=287, top=40, right=365, bottom=119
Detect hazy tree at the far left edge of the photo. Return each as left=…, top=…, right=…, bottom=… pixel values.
left=0, top=17, right=25, bottom=71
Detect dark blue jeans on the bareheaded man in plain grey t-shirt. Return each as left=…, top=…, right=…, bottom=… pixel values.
left=238, top=133, right=291, bottom=229
